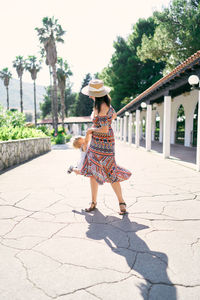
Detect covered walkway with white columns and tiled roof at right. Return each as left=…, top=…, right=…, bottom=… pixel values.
left=114, top=51, right=200, bottom=172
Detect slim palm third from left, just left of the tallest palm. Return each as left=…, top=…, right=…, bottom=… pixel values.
left=25, top=55, right=41, bottom=126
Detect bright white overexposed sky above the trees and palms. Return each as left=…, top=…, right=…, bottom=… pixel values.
left=0, top=0, right=170, bottom=92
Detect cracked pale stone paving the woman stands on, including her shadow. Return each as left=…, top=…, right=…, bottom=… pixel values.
left=0, top=143, right=200, bottom=300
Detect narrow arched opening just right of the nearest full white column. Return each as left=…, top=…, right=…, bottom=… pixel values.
left=175, top=104, right=185, bottom=145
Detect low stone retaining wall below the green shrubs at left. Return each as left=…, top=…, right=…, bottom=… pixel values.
left=0, top=137, right=51, bottom=171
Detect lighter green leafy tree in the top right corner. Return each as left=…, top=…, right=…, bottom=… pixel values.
left=138, top=0, right=200, bottom=74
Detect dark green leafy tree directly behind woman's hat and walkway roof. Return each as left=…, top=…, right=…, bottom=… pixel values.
left=100, top=18, right=165, bottom=110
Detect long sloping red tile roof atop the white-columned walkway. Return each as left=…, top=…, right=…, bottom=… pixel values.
left=117, top=50, right=200, bottom=114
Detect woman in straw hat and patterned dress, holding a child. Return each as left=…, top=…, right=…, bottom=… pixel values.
left=80, top=79, right=131, bottom=215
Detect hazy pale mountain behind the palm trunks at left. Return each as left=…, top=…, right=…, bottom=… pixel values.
left=0, top=79, right=45, bottom=112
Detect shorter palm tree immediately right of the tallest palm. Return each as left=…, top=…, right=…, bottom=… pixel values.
left=57, top=57, right=72, bottom=128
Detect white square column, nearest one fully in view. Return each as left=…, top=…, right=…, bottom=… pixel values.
left=163, top=96, right=171, bottom=158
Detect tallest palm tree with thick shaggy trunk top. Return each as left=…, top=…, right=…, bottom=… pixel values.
left=35, top=17, right=65, bottom=133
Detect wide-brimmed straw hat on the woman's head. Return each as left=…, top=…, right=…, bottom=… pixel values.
left=81, top=79, right=111, bottom=97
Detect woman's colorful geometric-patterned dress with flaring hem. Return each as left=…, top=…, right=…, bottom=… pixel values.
left=80, top=106, right=131, bottom=184
